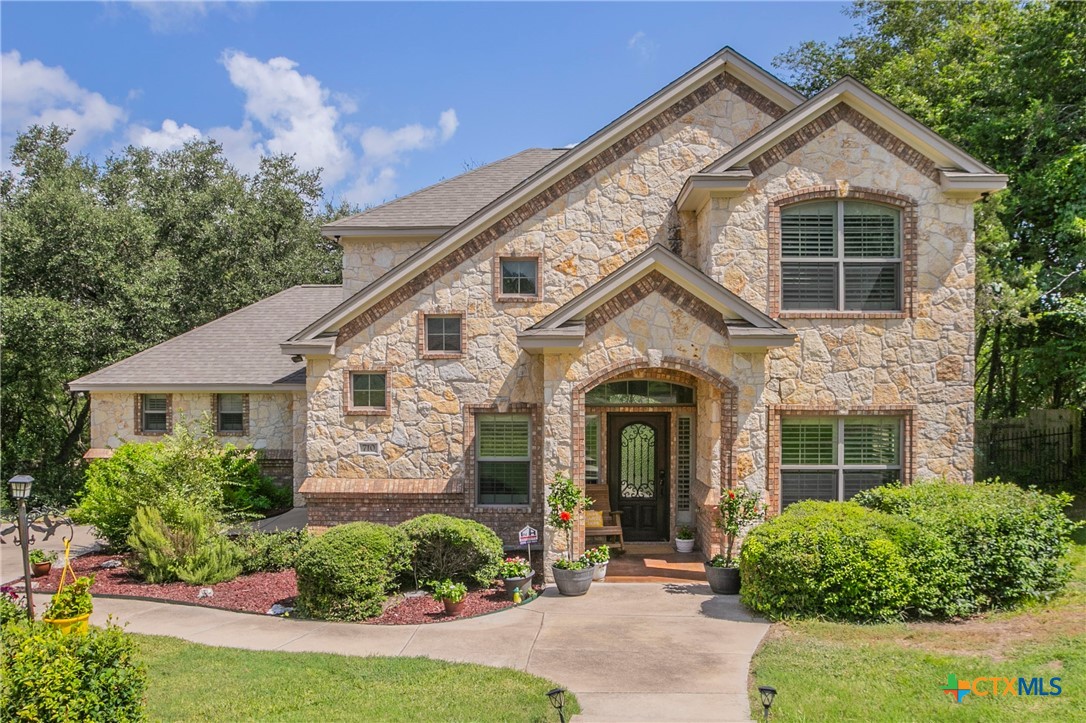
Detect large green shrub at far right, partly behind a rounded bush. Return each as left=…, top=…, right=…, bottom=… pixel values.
left=855, top=480, right=1077, bottom=612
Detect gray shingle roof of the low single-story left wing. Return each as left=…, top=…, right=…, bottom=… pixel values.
left=68, top=286, right=343, bottom=391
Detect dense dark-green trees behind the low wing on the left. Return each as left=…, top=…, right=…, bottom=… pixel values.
left=0, top=126, right=351, bottom=503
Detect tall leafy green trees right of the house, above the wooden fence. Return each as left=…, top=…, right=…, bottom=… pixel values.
left=774, top=0, right=1086, bottom=417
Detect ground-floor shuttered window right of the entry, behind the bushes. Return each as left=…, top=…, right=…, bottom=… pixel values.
left=781, top=416, right=901, bottom=509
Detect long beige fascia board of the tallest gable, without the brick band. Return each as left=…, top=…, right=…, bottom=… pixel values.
left=292, top=48, right=798, bottom=340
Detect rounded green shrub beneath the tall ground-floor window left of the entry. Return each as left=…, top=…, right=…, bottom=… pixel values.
left=399, top=515, right=505, bottom=585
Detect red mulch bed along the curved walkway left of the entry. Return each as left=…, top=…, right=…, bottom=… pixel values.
left=34, top=554, right=538, bottom=625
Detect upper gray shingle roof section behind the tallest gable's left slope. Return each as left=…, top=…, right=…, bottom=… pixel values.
left=324, top=148, right=566, bottom=233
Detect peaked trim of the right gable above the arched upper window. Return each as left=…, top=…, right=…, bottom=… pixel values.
left=703, top=76, right=995, bottom=174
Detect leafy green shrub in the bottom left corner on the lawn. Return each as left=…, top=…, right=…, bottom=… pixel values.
left=0, top=623, right=147, bottom=722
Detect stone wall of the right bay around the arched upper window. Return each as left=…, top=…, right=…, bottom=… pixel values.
left=698, top=112, right=975, bottom=482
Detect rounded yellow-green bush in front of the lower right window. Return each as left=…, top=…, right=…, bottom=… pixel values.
left=740, top=502, right=964, bottom=622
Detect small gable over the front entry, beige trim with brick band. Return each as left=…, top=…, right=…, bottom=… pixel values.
left=518, top=243, right=795, bottom=351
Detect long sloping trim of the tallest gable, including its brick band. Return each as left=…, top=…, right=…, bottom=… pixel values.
left=283, top=48, right=803, bottom=353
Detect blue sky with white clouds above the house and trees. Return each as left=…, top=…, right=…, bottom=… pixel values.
left=0, top=1, right=853, bottom=204
